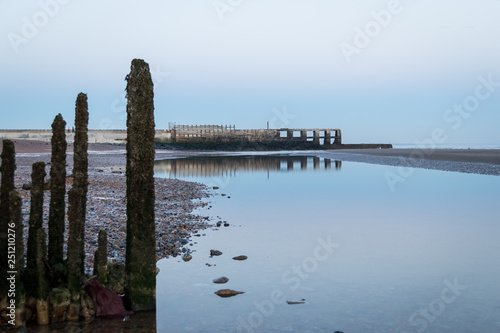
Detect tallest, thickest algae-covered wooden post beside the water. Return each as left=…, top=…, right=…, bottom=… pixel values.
left=126, top=59, right=156, bottom=310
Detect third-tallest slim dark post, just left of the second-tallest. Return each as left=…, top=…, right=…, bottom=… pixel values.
left=48, top=114, right=67, bottom=272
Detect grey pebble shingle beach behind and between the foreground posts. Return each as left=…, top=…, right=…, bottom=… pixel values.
left=11, top=152, right=211, bottom=273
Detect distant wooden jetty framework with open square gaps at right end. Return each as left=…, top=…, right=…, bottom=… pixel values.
left=172, top=125, right=342, bottom=146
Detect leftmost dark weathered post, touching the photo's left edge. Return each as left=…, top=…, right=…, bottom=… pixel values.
left=0, top=140, right=16, bottom=298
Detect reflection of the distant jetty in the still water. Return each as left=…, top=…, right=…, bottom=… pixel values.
left=155, top=155, right=342, bottom=178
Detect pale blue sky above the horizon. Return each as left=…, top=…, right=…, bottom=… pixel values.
left=0, top=0, right=500, bottom=144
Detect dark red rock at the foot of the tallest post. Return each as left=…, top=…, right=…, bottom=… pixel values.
left=86, top=279, right=133, bottom=316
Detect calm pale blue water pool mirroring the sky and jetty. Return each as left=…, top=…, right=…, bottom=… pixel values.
left=152, top=155, right=500, bottom=333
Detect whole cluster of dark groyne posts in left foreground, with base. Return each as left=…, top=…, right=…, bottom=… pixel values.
left=0, top=59, right=157, bottom=331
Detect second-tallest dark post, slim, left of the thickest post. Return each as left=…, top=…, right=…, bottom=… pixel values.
left=67, top=93, right=89, bottom=320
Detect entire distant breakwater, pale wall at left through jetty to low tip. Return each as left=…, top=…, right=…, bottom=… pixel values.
left=0, top=125, right=392, bottom=151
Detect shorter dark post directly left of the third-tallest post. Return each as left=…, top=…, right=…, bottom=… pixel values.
left=25, top=162, right=46, bottom=297
